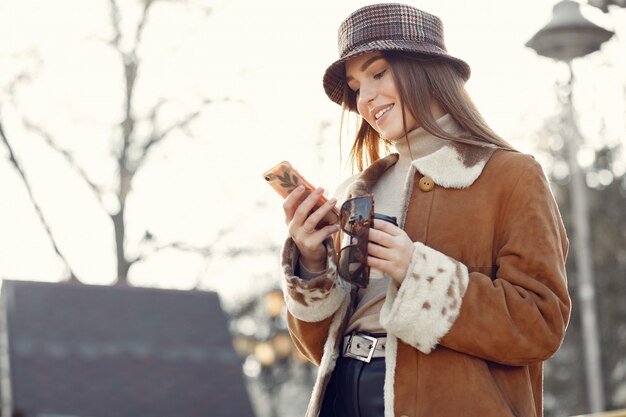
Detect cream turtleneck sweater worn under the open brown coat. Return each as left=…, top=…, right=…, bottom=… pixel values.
left=344, top=114, right=462, bottom=333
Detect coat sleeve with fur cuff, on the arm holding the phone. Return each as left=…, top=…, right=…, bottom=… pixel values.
left=281, top=234, right=350, bottom=365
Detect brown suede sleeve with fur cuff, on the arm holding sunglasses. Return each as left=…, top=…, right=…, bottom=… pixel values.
left=381, top=160, right=571, bottom=365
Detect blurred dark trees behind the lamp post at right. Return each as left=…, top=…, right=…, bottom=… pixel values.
left=539, top=104, right=626, bottom=417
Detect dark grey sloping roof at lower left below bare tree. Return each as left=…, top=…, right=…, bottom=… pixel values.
left=2, top=281, right=253, bottom=417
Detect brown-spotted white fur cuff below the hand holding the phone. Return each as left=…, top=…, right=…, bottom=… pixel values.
left=281, top=238, right=350, bottom=322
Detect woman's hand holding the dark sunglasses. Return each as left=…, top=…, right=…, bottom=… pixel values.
left=367, top=220, right=413, bottom=286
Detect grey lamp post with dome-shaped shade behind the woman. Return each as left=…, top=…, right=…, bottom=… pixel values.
left=526, top=0, right=613, bottom=413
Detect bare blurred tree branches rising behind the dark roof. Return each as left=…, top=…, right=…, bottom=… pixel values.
left=0, top=0, right=239, bottom=285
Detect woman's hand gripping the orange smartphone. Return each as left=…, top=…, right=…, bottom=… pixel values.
left=283, top=185, right=339, bottom=271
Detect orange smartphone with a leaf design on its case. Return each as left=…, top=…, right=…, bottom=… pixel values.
left=263, top=161, right=339, bottom=229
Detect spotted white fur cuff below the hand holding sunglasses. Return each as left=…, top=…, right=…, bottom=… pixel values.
left=380, top=242, right=469, bottom=353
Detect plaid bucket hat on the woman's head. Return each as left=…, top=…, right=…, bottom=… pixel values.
left=323, top=3, right=470, bottom=105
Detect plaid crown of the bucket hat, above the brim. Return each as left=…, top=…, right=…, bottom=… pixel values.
left=338, top=3, right=446, bottom=57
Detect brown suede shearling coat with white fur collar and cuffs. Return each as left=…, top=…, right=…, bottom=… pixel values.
left=282, top=142, right=570, bottom=417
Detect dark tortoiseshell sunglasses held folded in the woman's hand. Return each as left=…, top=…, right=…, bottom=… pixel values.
left=338, top=194, right=374, bottom=288
